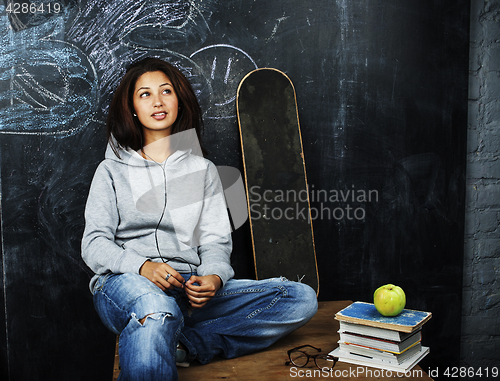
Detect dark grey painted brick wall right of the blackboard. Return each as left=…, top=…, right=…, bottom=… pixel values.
left=461, top=0, right=500, bottom=372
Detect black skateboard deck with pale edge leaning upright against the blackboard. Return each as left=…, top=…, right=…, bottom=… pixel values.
left=236, top=68, right=319, bottom=293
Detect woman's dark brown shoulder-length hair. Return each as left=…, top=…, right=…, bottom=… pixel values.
left=106, top=58, right=205, bottom=156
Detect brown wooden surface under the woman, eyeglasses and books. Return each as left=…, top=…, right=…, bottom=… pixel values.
left=178, top=300, right=432, bottom=381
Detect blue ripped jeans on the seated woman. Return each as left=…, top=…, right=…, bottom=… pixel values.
left=94, top=274, right=317, bottom=381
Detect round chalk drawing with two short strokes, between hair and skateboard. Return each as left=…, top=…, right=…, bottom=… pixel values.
left=190, top=44, right=257, bottom=119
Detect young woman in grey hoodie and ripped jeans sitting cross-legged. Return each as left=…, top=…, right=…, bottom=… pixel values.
left=82, top=58, right=317, bottom=381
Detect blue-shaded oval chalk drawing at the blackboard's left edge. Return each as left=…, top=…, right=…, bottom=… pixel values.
left=0, top=8, right=99, bottom=136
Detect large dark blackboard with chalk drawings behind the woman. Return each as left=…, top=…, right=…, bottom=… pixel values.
left=0, top=0, right=469, bottom=380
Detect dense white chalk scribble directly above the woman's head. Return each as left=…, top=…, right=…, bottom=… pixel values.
left=66, top=0, right=215, bottom=115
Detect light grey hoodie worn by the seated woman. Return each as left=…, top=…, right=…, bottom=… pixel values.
left=82, top=145, right=234, bottom=291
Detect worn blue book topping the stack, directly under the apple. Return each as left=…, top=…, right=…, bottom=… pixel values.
left=335, top=302, right=432, bottom=332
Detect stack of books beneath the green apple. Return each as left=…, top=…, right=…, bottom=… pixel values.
left=330, top=302, right=432, bottom=373
